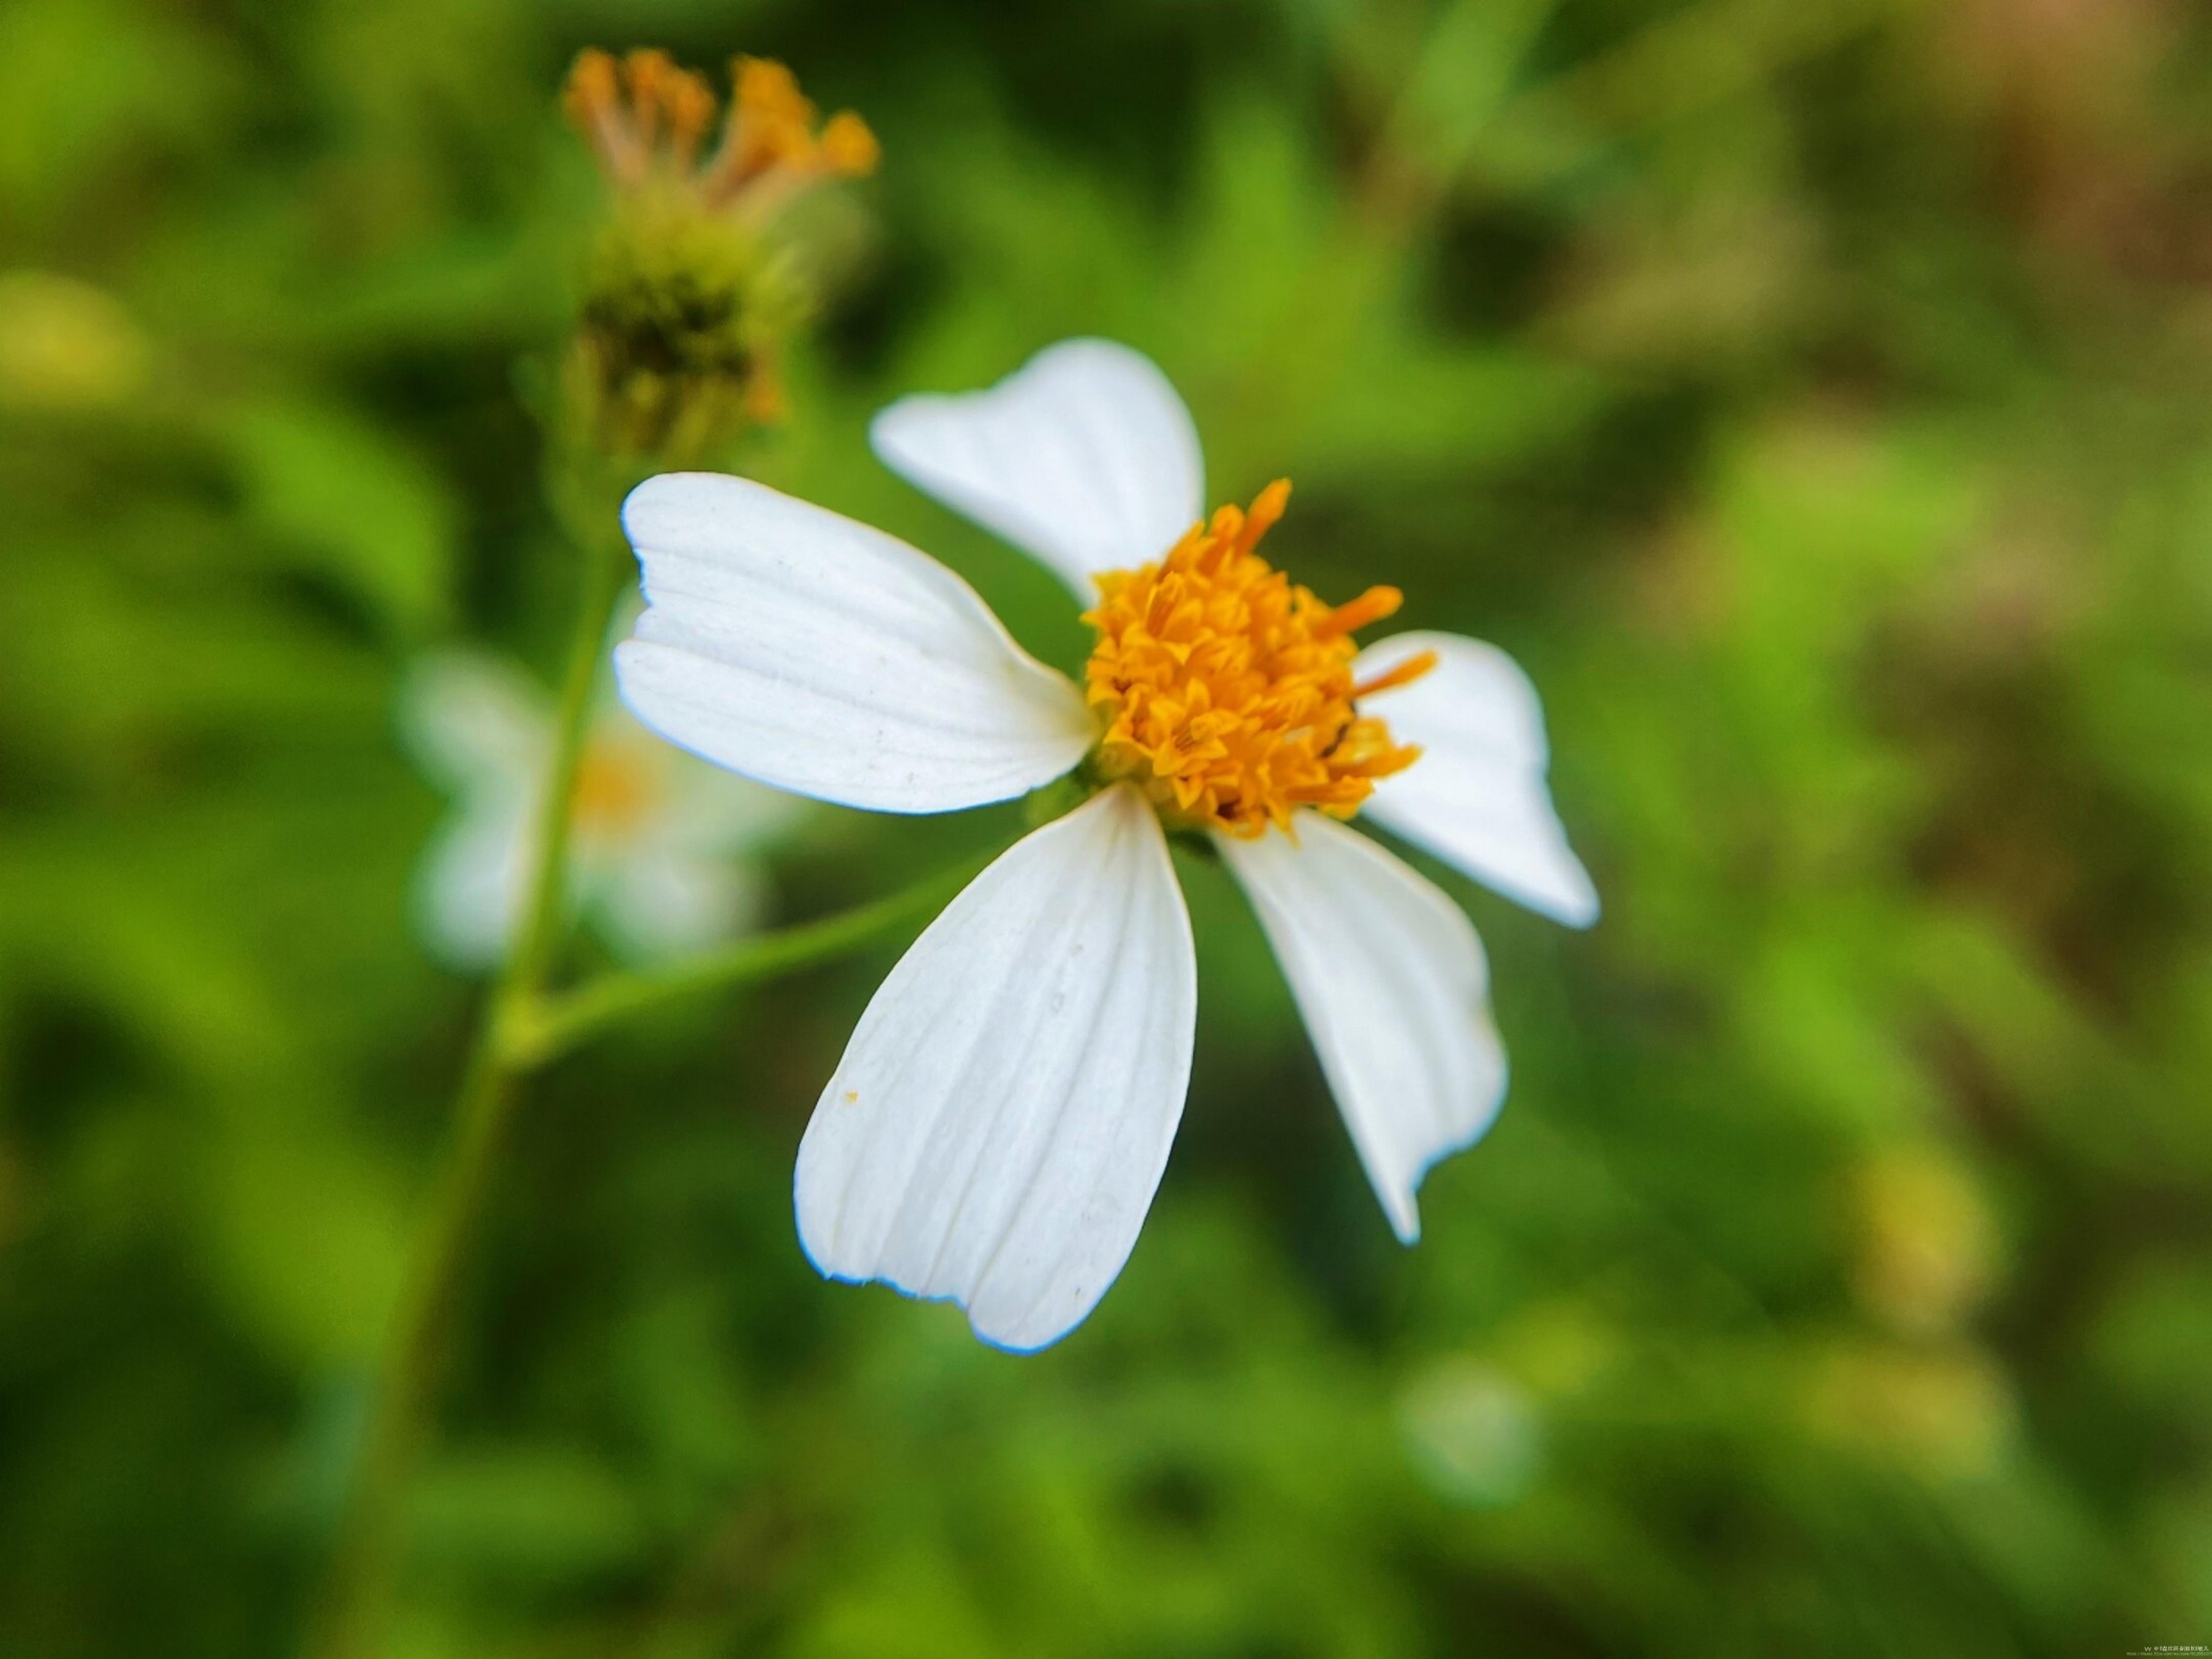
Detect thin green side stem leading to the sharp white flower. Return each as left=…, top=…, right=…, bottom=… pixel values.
left=500, top=852, right=998, bottom=1071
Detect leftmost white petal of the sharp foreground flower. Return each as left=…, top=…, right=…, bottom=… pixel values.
left=615, top=473, right=1095, bottom=812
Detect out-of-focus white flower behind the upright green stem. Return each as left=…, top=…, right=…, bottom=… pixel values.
left=400, top=653, right=805, bottom=969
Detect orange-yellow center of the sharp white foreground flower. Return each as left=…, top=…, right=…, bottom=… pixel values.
left=1084, top=480, right=1435, bottom=840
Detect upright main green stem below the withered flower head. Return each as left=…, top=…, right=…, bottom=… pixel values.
left=307, top=513, right=628, bottom=1659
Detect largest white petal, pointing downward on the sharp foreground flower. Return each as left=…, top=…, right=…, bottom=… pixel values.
left=796, top=785, right=1199, bottom=1352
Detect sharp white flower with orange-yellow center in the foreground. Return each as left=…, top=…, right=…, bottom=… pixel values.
left=615, top=341, right=1597, bottom=1352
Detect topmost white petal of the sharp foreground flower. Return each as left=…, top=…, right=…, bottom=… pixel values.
left=869, top=341, right=1206, bottom=601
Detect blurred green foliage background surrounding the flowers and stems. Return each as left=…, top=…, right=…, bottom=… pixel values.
left=0, top=0, right=2212, bottom=1659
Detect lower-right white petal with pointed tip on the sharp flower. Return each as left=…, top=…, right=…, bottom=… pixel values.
left=1214, top=812, right=1506, bottom=1243
